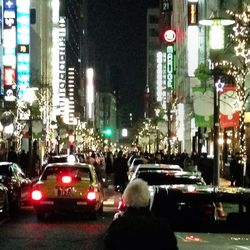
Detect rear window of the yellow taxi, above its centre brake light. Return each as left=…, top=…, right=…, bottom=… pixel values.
left=41, top=167, right=92, bottom=181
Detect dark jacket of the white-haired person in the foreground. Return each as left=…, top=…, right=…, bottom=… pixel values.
left=104, top=207, right=178, bottom=250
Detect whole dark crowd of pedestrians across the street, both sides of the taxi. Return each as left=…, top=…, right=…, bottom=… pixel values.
left=0, top=146, right=249, bottom=188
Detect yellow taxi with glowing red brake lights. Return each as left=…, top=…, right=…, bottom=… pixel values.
left=31, top=162, right=104, bottom=220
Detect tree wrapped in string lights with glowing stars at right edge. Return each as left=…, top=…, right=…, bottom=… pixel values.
left=215, top=10, right=250, bottom=164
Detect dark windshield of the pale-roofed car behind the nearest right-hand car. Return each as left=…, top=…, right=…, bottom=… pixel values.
left=137, top=171, right=204, bottom=186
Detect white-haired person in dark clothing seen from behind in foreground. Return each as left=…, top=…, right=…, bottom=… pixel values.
left=103, top=178, right=178, bottom=250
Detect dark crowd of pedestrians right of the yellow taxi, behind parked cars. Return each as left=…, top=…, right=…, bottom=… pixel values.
left=99, top=151, right=249, bottom=190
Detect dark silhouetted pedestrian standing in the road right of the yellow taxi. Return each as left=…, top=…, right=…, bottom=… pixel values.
left=113, top=150, right=128, bottom=192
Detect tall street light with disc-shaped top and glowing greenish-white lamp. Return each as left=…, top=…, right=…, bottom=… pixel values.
left=199, top=14, right=235, bottom=186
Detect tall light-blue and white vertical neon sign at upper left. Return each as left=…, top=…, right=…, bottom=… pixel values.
left=16, top=0, right=30, bottom=100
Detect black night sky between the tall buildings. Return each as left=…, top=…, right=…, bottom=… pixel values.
left=88, top=0, right=158, bottom=120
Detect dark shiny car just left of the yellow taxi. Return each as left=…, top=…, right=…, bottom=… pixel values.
left=0, top=162, right=32, bottom=211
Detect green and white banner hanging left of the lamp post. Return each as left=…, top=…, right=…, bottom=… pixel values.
left=192, top=87, right=214, bottom=128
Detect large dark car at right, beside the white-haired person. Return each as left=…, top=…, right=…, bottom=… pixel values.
left=114, top=185, right=250, bottom=250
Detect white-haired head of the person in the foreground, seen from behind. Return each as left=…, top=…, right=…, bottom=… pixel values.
left=122, top=178, right=150, bottom=208
